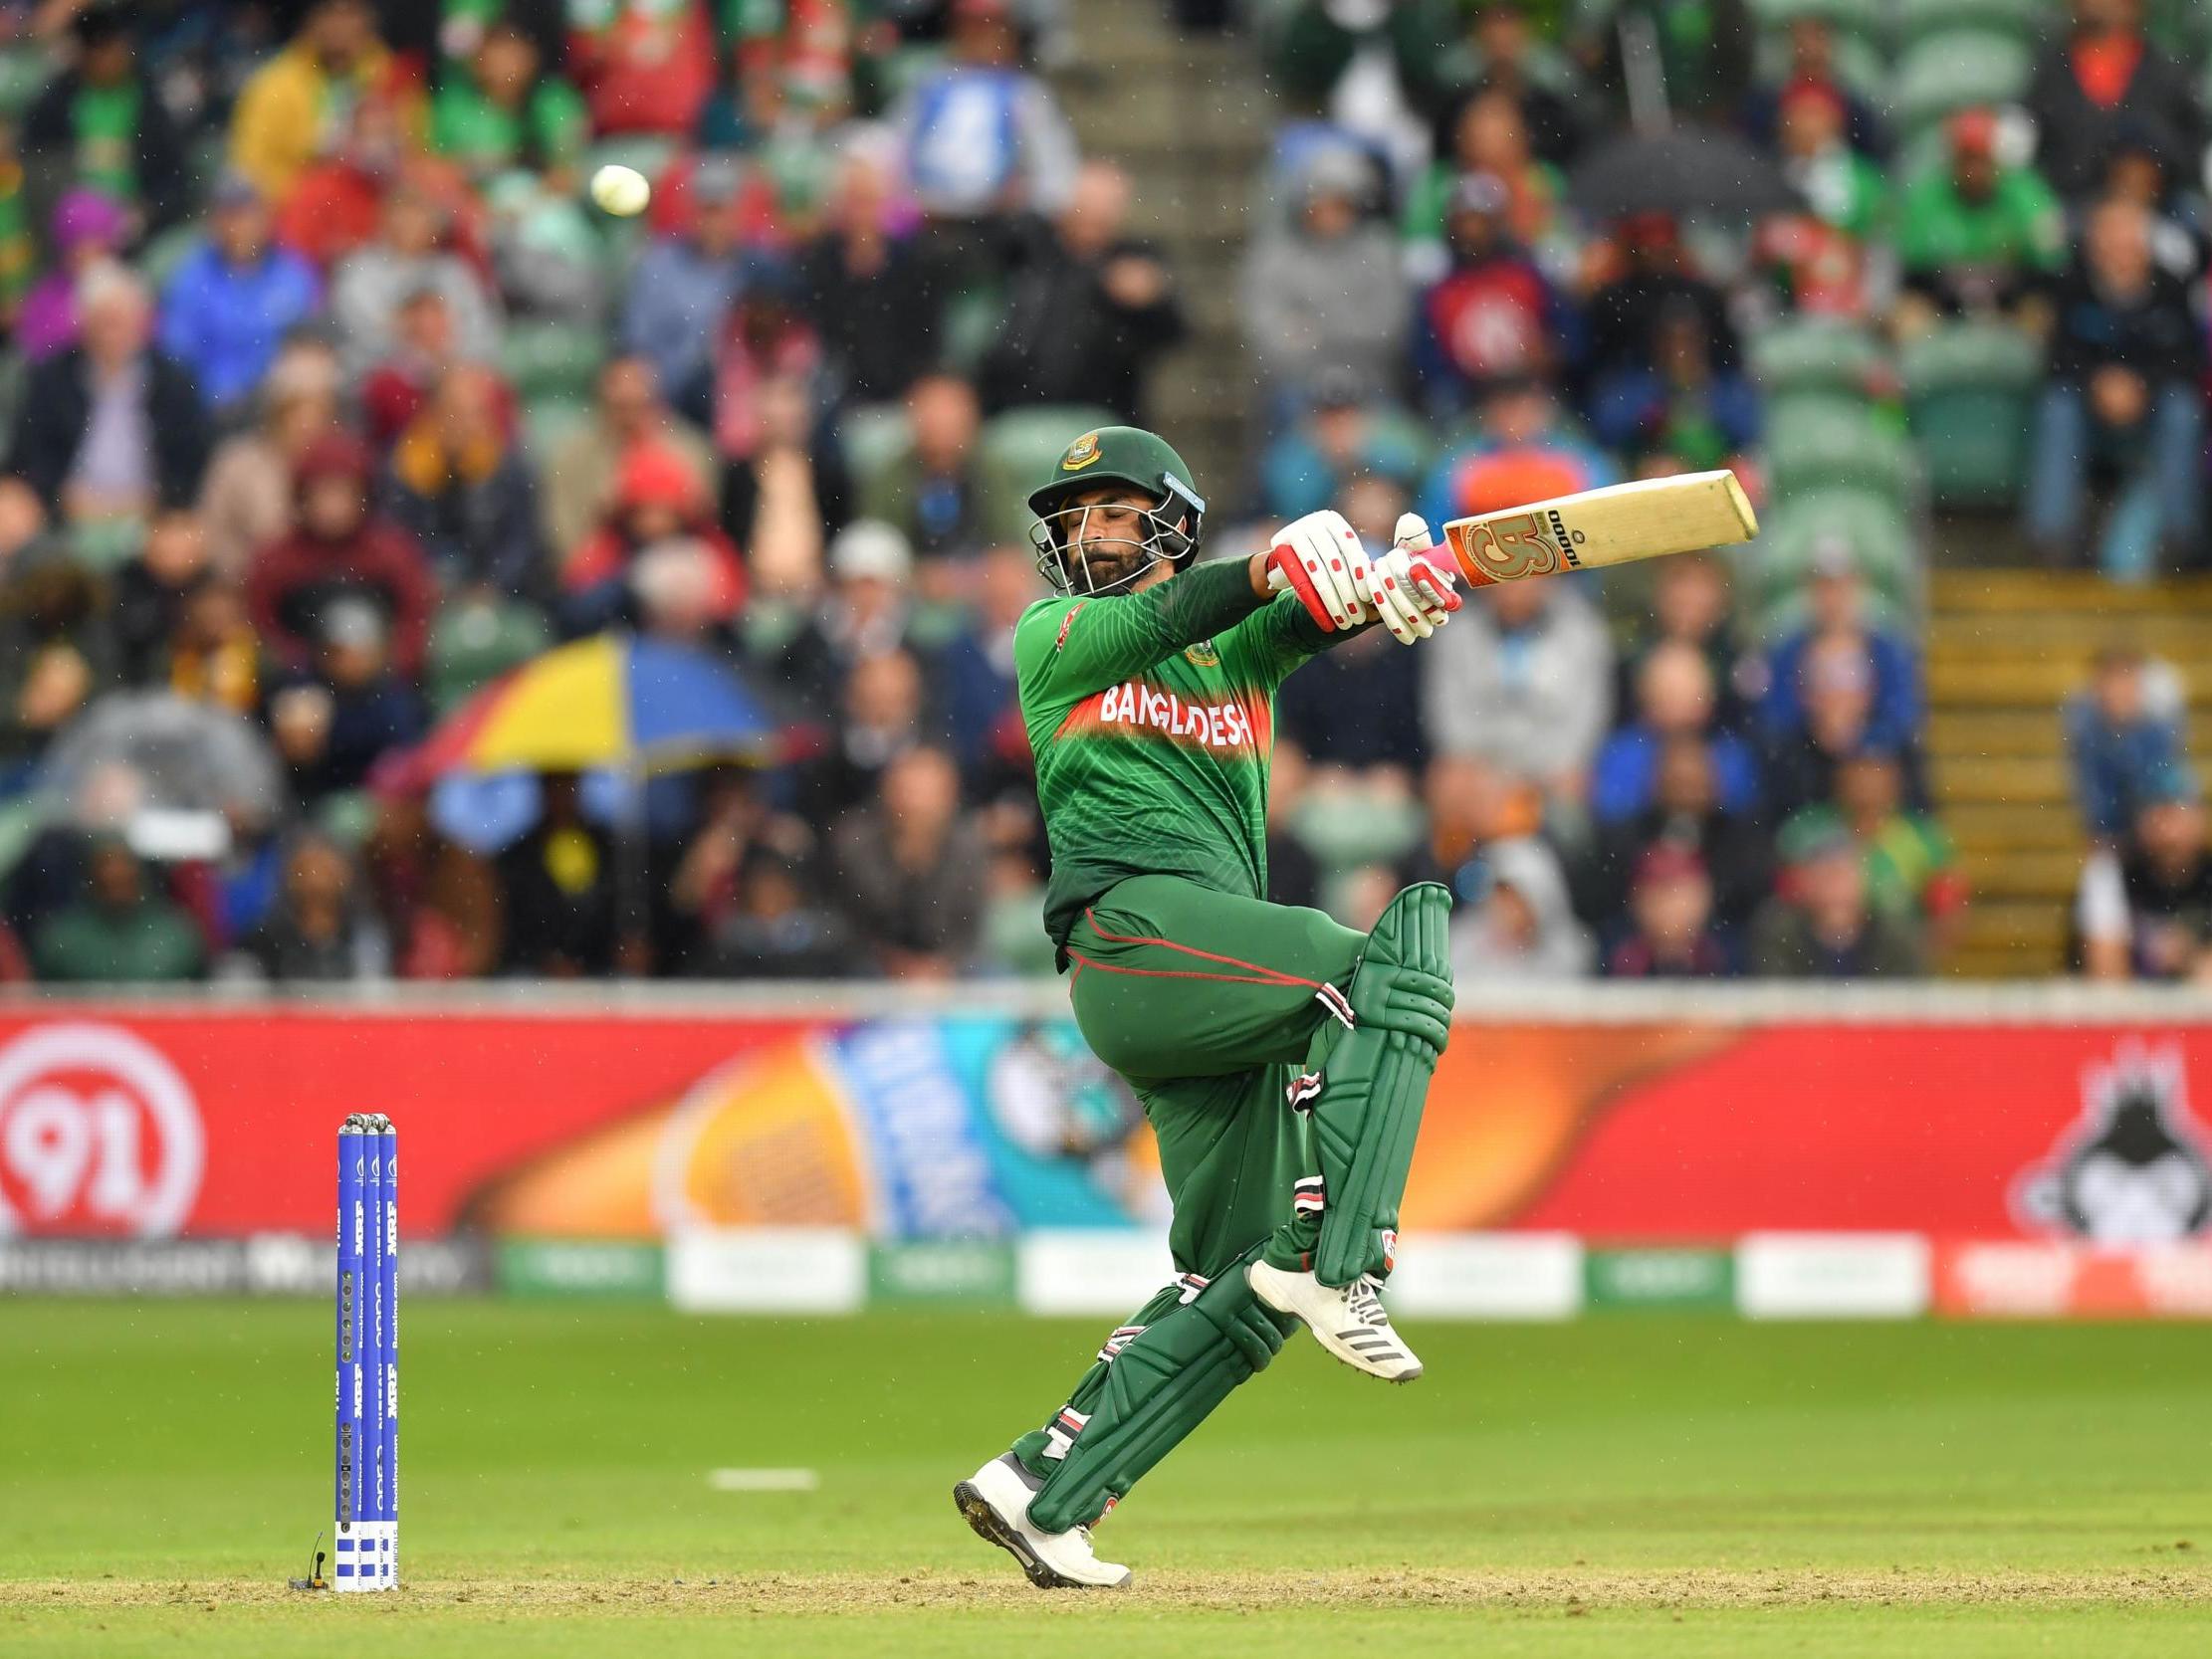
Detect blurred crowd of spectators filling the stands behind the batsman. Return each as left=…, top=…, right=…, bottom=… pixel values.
left=0, top=0, right=2212, bottom=982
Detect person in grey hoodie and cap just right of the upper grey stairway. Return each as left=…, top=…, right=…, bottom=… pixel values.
left=1238, top=146, right=1409, bottom=431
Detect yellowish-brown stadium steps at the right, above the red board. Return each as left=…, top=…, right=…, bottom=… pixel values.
left=1926, top=570, right=2212, bottom=980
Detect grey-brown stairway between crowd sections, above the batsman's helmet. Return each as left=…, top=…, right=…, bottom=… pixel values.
left=1053, top=0, right=1276, bottom=503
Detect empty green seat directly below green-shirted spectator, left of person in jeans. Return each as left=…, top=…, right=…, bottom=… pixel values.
left=1904, top=323, right=2044, bottom=507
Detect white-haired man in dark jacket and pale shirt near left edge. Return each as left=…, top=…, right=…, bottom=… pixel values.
left=7, top=266, right=208, bottom=524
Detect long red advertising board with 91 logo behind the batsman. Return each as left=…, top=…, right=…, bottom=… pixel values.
left=0, top=1006, right=2212, bottom=1247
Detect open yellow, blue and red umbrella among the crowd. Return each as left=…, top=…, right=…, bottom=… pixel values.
left=380, top=635, right=780, bottom=787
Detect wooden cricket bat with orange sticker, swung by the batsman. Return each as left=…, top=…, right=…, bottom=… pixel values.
left=1442, top=469, right=1758, bottom=588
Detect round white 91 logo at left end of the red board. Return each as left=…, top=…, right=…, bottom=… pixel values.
left=0, top=1022, right=206, bottom=1239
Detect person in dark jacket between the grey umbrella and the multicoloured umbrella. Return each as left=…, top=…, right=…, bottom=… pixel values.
left=266, top=593, right=425, bottom=803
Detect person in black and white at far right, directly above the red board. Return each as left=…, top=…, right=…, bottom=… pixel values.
left=2073, top=765, right=2212, bottom=982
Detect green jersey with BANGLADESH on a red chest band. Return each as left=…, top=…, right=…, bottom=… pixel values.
left=1013, top=559, right=1334, bottom=946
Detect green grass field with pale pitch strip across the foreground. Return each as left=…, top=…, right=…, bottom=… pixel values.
left=0, top=1299, right=2212, bottom=1659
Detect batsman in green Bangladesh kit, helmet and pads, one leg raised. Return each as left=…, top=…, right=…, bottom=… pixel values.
left=954, top=427, right=1460, bottom=1588
